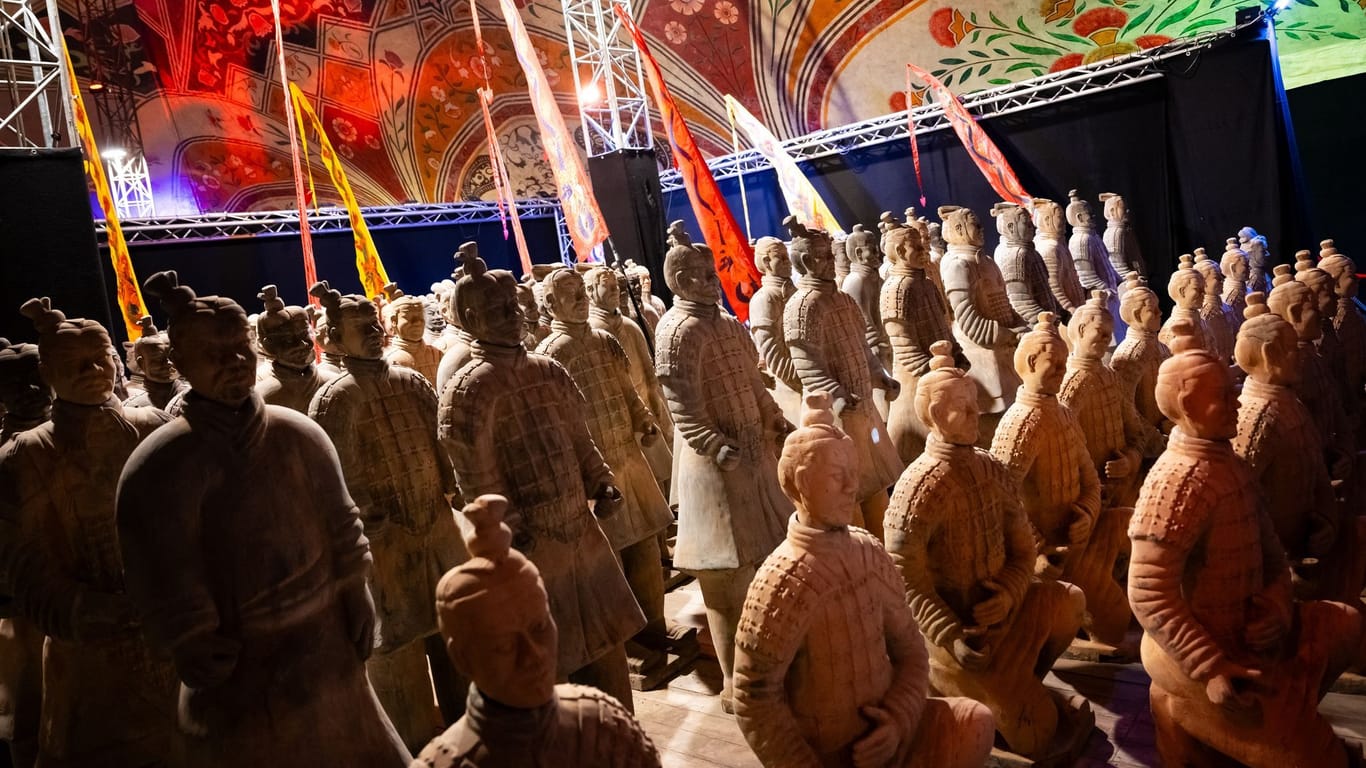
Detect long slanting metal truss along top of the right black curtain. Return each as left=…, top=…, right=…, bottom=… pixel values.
left=660, top=16, right=1265, bottom=193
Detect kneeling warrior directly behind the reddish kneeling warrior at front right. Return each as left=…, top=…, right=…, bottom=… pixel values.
left=1233, top=292, right=1350, bottom=600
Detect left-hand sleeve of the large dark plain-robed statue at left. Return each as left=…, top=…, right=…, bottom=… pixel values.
left=116, top=436, right=219, bottom=650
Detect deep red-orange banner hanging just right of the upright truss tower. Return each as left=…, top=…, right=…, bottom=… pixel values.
left=612, top=5, right=759, bottom=323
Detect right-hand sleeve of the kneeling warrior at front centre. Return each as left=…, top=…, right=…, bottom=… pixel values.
left=870, top=548, right=930, bottom=739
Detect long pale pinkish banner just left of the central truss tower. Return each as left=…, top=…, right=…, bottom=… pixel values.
left=499, top=0, right=608, bottom=261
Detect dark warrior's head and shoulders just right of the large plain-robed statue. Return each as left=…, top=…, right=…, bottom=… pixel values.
left=257, top=286, right=336, bottom=413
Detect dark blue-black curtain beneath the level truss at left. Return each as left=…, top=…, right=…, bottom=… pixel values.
left=94, top=213, right=560, bottom=336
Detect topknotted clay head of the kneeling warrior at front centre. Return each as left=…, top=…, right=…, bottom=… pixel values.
left=777, top=392, right=859, bottom=530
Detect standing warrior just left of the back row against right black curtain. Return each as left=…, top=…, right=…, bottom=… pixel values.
left=879, top=221, right=967, bottom=463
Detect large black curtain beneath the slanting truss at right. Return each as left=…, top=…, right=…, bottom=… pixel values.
left=665, top=27, right=1305, bottom=297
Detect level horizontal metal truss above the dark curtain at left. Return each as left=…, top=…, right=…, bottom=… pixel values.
left=96, top=198, right=560, bottom=245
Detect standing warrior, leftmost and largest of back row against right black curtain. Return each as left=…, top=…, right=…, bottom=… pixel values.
left=939, top=205, right=1029, bottom=444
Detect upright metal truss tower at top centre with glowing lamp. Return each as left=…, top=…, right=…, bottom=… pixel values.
left=561, top=0, right=654, bottom=157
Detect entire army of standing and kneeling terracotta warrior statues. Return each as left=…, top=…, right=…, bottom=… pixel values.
left=0, top=195, right=1366, bottom=765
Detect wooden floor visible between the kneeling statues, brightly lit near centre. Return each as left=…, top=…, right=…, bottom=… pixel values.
left=635, top=584, right=1366, bottom=768
